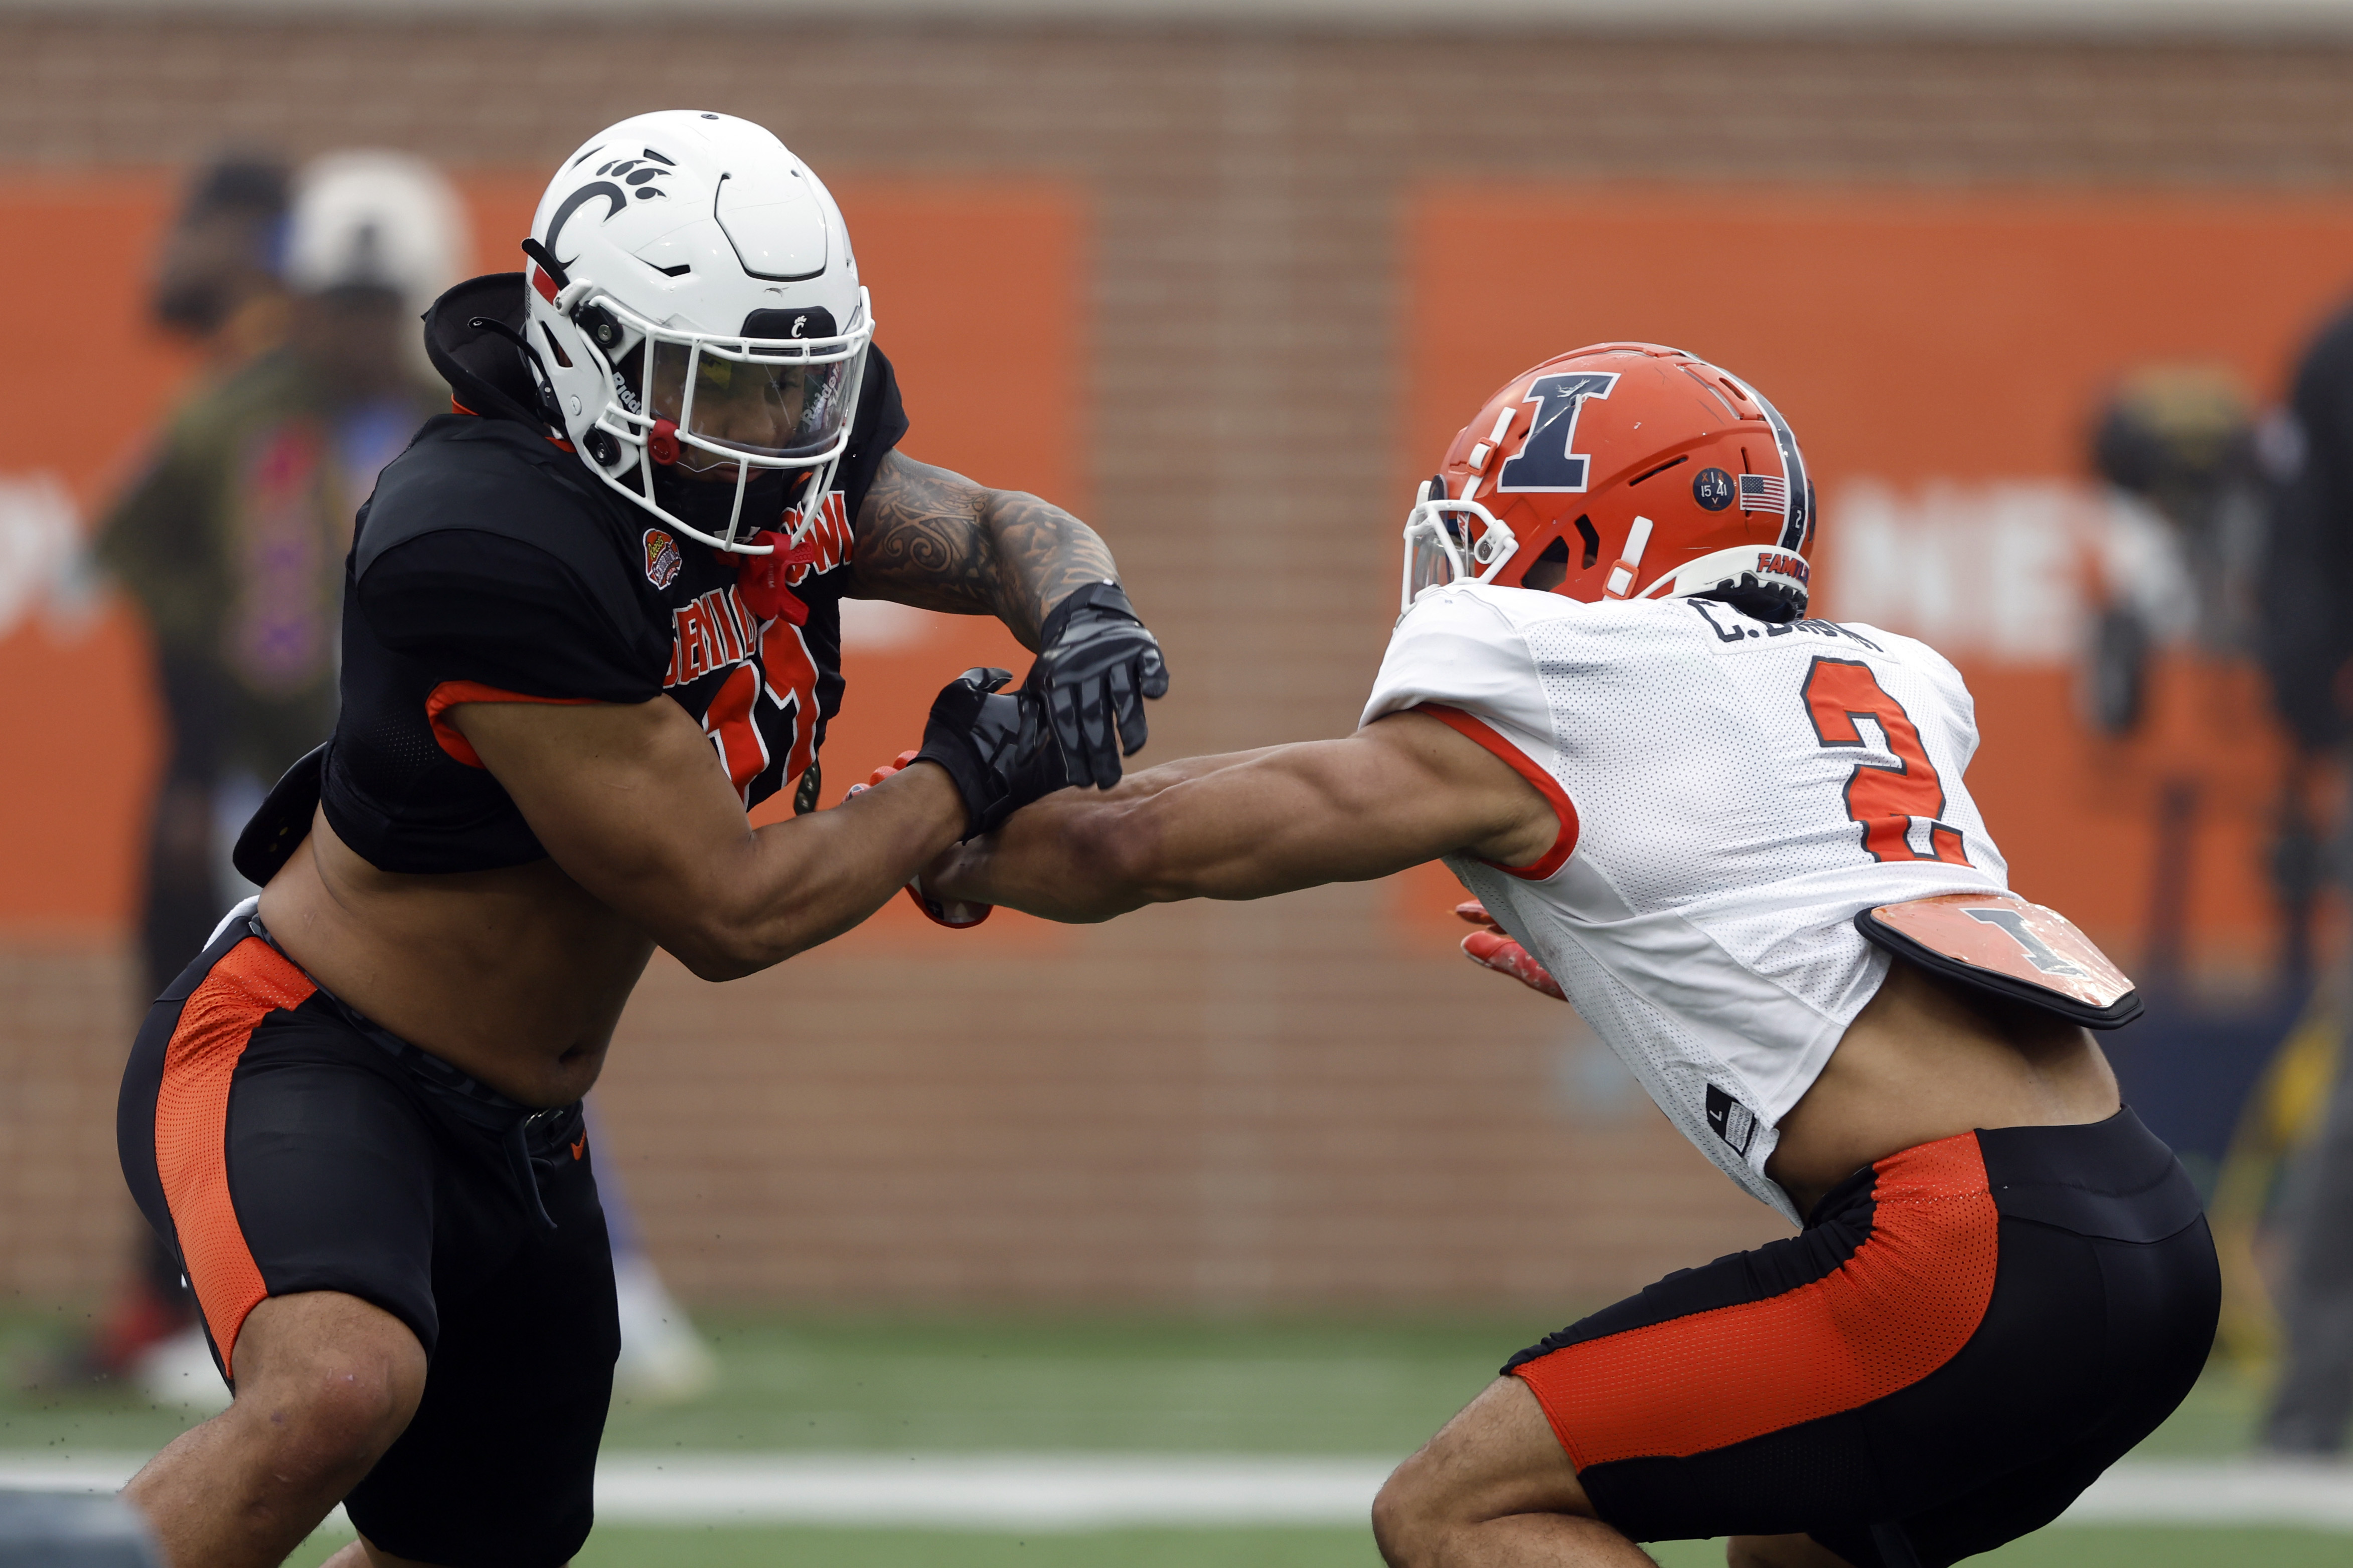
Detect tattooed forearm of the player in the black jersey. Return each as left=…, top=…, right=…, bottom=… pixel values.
left=849, top=451, right=1120, bottom=651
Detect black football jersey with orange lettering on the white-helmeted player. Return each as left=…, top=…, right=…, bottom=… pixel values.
left=320, top=273, right=906, bottom=872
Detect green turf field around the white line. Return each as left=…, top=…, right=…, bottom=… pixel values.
left=0, top=1316, right=2353, bottom=1568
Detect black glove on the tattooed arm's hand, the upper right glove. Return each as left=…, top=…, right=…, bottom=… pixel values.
left=1021, top=583, right=1169, bottom=790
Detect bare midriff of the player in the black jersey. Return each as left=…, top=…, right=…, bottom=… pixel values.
left=261, top=811, right=654, bottom=1105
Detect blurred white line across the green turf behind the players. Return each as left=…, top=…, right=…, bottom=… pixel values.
left=0, top=1451, right=2353, bottom=1530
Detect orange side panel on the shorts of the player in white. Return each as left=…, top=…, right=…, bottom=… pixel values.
left=1513, top=1133, right=2000, bottom=1469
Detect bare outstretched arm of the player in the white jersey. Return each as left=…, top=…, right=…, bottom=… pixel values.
left=925, top=713, right=1562, bottom=922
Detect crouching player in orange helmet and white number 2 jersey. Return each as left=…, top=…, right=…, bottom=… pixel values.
left=925, top=343, right=2219, bottom=1568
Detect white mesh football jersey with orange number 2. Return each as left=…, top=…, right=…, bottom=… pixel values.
left=1362, top=583, right=2007, bottom=1220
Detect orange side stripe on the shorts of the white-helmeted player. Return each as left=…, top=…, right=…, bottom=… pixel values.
left=155, top=936, right=318, bottom=1377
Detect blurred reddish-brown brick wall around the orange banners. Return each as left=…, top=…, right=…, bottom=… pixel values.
left=0, top=17, right=2353, bottom=1307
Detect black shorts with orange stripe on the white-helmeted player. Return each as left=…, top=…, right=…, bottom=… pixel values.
left=115, top=919, right=619, bottom=1568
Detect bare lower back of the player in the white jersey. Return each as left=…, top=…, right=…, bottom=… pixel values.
left=1765, top=959, right=2120, bottom=1213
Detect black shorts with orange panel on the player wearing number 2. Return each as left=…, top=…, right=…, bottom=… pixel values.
left=1504, top=1110, right=2221, bottom=1568
